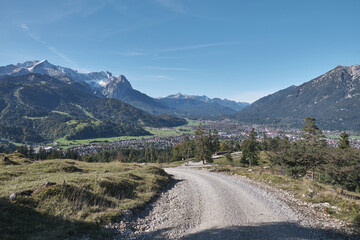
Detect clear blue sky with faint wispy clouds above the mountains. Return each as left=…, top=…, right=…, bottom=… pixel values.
left=0, top=0, right=360, bottom=102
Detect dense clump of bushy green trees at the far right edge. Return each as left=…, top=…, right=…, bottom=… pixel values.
left=270, top=118, right=360, bottom=192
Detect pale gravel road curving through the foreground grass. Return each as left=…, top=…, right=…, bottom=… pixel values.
left=110, top=167, right=358, bottom=239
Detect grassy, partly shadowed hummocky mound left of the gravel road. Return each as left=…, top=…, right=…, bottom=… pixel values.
left=0, top=154, right=169, bottom=239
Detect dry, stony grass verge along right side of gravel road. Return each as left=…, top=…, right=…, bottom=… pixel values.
left=211, top=152, right=360, bottom=231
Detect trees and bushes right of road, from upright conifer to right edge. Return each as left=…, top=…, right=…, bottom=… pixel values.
left=236, top=117, right=360, bottom=192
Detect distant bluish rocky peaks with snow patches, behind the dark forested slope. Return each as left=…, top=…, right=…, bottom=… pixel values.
left=0, top=60, right=248, bottom=117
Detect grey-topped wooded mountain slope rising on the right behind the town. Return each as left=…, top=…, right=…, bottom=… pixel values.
left=236, top=65, right=360, bottom=131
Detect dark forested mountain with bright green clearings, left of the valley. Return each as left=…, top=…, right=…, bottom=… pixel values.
left=0, top=73, right=186, bottom=142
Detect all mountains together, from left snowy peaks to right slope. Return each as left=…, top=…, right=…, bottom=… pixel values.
left=0, top=60, right=360, bottom=141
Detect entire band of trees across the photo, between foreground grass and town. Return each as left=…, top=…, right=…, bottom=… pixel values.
left=11, top=118, right=360, bottom=192
